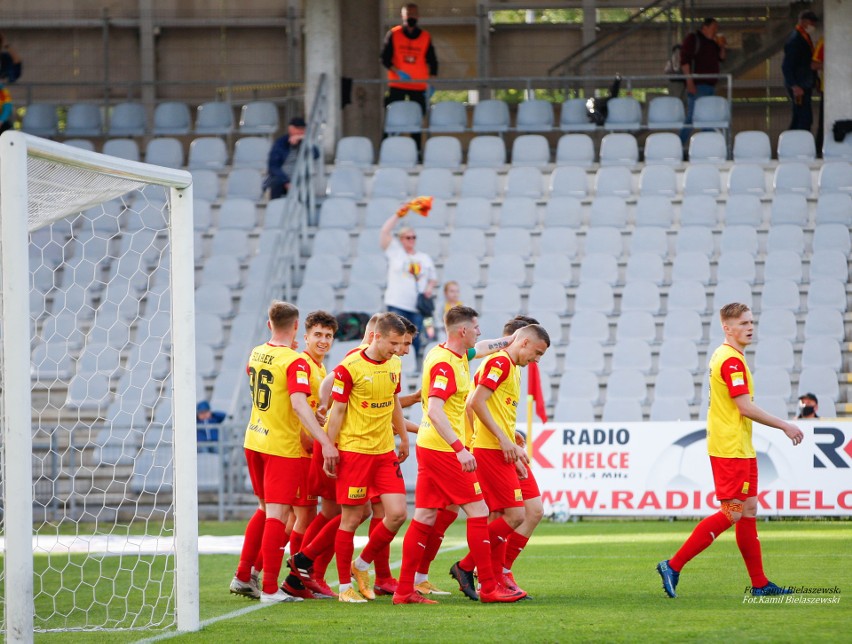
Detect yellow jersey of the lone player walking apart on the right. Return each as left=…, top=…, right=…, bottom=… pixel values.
left=707, top=344, right=755, bottom=458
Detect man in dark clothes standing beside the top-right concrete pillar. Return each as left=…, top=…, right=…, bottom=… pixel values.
left=781, top=11, right=819, bottom=132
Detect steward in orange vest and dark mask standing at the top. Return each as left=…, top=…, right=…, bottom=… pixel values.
left=381, top=2, right=438, bottom=150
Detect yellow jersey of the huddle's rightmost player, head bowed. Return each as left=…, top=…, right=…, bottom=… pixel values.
left=473, top=351, right=521, bottom=449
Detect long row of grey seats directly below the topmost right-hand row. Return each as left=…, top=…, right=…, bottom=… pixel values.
left=342, top=130, right=816, bottom=170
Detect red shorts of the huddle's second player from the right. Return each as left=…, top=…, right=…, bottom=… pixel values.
left=414, top=445, right=482, bottom=508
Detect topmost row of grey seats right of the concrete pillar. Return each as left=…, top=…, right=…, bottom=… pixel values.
left=384, top=96, right=731, bottom=134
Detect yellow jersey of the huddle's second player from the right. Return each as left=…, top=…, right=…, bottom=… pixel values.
left=417, top=344, right=471, bottom=452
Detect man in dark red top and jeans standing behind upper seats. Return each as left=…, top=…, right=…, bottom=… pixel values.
left=680, top=18, right=727, bottom=145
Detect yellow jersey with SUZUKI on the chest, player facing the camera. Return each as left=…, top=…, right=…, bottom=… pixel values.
left=331, top=349, right=401, bottom=454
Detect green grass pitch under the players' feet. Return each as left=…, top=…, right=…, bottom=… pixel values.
left=26, top=520, right=852, bottom=643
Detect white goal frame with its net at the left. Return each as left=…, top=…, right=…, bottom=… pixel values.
left=0, top=131, right=199, bottom=642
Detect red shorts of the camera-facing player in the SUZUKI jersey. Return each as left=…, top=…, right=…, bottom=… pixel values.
left=337, top=451, right=405, bottom=505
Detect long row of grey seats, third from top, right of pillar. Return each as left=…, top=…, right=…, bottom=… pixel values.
left=326, top=161, right=852, bottom=201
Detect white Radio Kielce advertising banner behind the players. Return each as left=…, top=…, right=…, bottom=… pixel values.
left=519, top=420, right=852, bottom=519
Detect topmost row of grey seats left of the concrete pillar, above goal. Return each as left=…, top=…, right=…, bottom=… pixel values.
left=21, top=101, right=279, bottom=137
